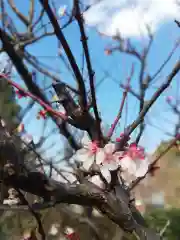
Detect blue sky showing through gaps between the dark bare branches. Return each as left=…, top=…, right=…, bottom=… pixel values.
left=0, top=0, right=180, bottom=161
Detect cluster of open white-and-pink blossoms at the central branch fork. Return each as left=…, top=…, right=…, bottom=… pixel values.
left=74, top=135, right=149, bottom=188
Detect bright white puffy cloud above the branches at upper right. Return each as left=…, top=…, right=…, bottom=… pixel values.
left=84, top=0, right=180, bottom=37
